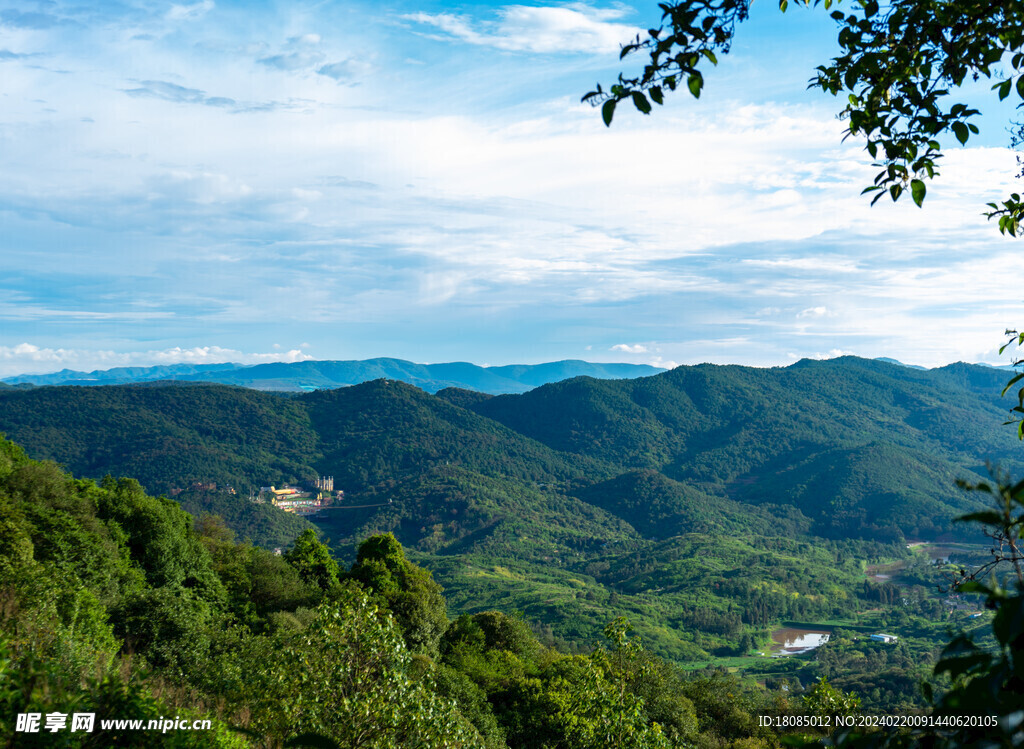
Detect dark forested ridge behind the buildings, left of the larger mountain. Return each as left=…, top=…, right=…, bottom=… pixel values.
left=0, top=380, right=609, bottom=493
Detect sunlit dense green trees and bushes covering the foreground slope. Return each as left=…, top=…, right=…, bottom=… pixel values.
left=0, top=441, right=798, bottom=749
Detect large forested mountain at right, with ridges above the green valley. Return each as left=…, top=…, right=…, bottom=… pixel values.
left=469, top=358, right=1020, bottom=540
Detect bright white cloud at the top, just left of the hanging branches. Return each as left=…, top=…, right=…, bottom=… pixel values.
left=403, top=3, right=641, bottom=54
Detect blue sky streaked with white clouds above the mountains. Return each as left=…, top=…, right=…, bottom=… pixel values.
left=0, top=0, right=1024, bottom=376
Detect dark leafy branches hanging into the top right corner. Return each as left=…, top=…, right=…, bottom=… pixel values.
left=583, top=0, right=1024, bottom=231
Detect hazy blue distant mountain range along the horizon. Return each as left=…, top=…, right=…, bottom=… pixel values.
left=0, top=359, right=665, bottom=394
